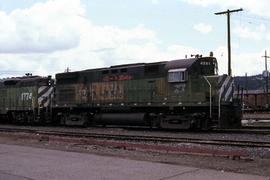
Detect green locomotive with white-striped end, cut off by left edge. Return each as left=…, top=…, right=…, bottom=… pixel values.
left=0, top=74, right=54, bottom=123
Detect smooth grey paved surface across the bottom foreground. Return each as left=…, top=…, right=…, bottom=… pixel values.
left=0, top=144, right=269, bottom=180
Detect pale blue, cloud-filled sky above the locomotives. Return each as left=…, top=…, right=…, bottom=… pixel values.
left=0, top=0, right=270, bottom=78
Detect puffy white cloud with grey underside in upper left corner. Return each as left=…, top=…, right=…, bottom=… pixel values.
left=0, top=0, right=84, bottom=53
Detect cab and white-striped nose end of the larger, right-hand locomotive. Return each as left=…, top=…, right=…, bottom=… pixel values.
left=161, top=57, right=239, bottom=129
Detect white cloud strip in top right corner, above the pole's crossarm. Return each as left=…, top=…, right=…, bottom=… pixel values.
left=179, top=0, right=270, bottom=17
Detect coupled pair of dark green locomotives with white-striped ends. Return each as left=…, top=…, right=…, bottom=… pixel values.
left=0, top=57, right=241, bottom=129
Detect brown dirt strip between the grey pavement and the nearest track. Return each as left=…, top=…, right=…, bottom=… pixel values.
left=0, top=138, right=270, bottom=176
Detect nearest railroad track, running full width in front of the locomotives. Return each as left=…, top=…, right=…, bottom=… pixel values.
left=0, top=128, right=270, bottom=148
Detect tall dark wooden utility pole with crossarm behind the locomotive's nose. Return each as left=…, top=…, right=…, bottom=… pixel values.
left=215, top=8, right=243, bottom=76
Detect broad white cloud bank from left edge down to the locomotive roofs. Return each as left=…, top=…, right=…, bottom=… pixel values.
left=0, top=0, right=198, bottom=77
